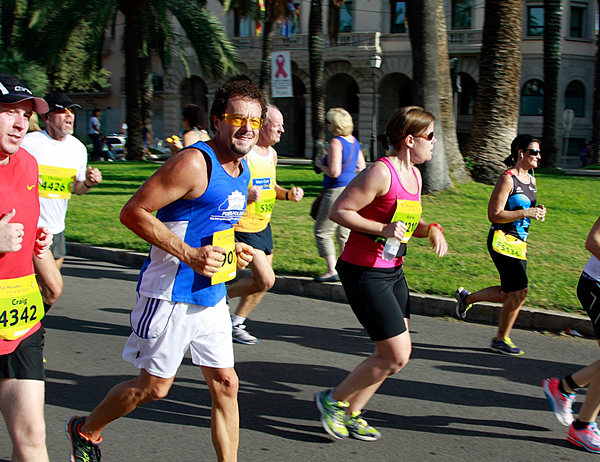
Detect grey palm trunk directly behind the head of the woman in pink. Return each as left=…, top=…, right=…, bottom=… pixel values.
left=406, top=0, right=452, bottom=194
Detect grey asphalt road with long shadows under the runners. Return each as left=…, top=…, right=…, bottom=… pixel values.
left=0, top=257, right=598, bottom=462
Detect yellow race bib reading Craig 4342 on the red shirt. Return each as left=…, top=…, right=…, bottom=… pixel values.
left=0, top=274, right=44, bottom=340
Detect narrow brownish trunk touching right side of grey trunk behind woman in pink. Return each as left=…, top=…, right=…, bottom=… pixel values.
left=437, top=0, right=470, bottom=183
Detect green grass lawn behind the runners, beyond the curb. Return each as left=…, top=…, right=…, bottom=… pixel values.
left=66, top=162, right=600, bottom=311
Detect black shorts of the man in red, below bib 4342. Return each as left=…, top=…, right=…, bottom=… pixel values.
left=0, top=326, right=46, bottom=380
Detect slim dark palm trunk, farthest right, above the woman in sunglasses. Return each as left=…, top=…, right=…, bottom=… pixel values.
left=541, top=0, right=566, bottom=167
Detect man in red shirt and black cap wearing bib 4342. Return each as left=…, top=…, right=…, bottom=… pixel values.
left=0, top=74, right=52, bottom=462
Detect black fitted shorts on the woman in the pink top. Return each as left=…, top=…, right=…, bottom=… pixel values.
left=336, top=260, right=410, bottom=342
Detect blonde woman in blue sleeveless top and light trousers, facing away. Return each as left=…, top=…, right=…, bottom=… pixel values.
left=314, top=108, right=366, bottom=282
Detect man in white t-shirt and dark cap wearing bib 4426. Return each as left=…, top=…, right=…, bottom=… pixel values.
left=21, top=92, right=102, bottom=311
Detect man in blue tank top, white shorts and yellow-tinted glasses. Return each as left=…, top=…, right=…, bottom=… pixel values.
left=67, top=81, right=266, bottom=461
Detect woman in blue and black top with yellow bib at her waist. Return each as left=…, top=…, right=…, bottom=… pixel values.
left=455, top=135, right=546, bottom=356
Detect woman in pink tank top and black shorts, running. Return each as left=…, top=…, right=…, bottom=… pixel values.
left=315, top=106, right=448, bottom=441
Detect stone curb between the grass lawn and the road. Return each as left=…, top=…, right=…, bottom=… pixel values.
left=67, top=242, right=594, bottom=337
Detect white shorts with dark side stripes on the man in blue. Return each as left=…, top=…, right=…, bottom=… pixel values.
left=123, top=295, right=234, bottom=379
